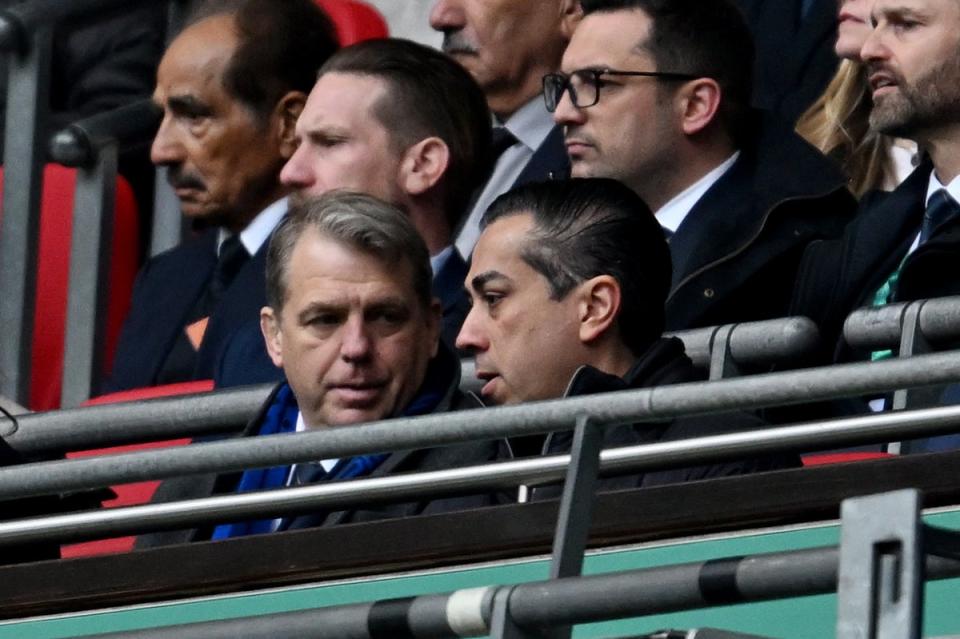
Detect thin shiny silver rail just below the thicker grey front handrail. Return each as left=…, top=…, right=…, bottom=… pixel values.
left=0, top=406, right=960, bottom=546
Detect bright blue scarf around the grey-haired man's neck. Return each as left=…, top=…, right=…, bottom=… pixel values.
left=216, top=346, right=459, bottom=540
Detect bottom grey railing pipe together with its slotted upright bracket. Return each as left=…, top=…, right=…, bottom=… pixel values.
left=62, top=490, right=960, bottom=639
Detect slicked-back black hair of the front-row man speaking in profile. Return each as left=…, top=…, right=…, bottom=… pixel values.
left=480, top=178, right=673, bottom=357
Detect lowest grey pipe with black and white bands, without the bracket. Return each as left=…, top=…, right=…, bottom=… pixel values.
left=71, top=547, right=960, bottom=639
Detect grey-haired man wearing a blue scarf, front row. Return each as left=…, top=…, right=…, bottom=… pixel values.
left=140, top=191, right=502, bottom=546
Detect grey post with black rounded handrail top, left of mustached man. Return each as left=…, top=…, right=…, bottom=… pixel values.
left=50, top=100, right=159, bottom=407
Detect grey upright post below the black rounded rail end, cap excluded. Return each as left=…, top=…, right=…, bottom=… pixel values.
left=60, top=143, right=118, bottom=408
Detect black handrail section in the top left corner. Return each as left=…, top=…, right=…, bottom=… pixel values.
left=0, top=0, right=157, bottom=51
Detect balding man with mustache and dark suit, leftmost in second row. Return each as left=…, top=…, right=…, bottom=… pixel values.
left=105, top=0, right=337, bottom=391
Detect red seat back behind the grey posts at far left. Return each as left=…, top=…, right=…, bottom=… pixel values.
left=0, top=164, right=139, bottom=410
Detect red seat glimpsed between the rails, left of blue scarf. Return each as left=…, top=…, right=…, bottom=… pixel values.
left=60, top=379, right=213, bottom=557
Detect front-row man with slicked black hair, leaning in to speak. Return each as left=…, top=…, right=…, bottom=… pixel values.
left=457, top=178, right=797, bottom=495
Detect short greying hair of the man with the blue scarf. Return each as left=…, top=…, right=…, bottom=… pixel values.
left=266, top=190, right=433, bottom=315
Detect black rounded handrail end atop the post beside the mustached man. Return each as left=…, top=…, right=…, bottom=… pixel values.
left=50, top=100, right=160, bottom=167
